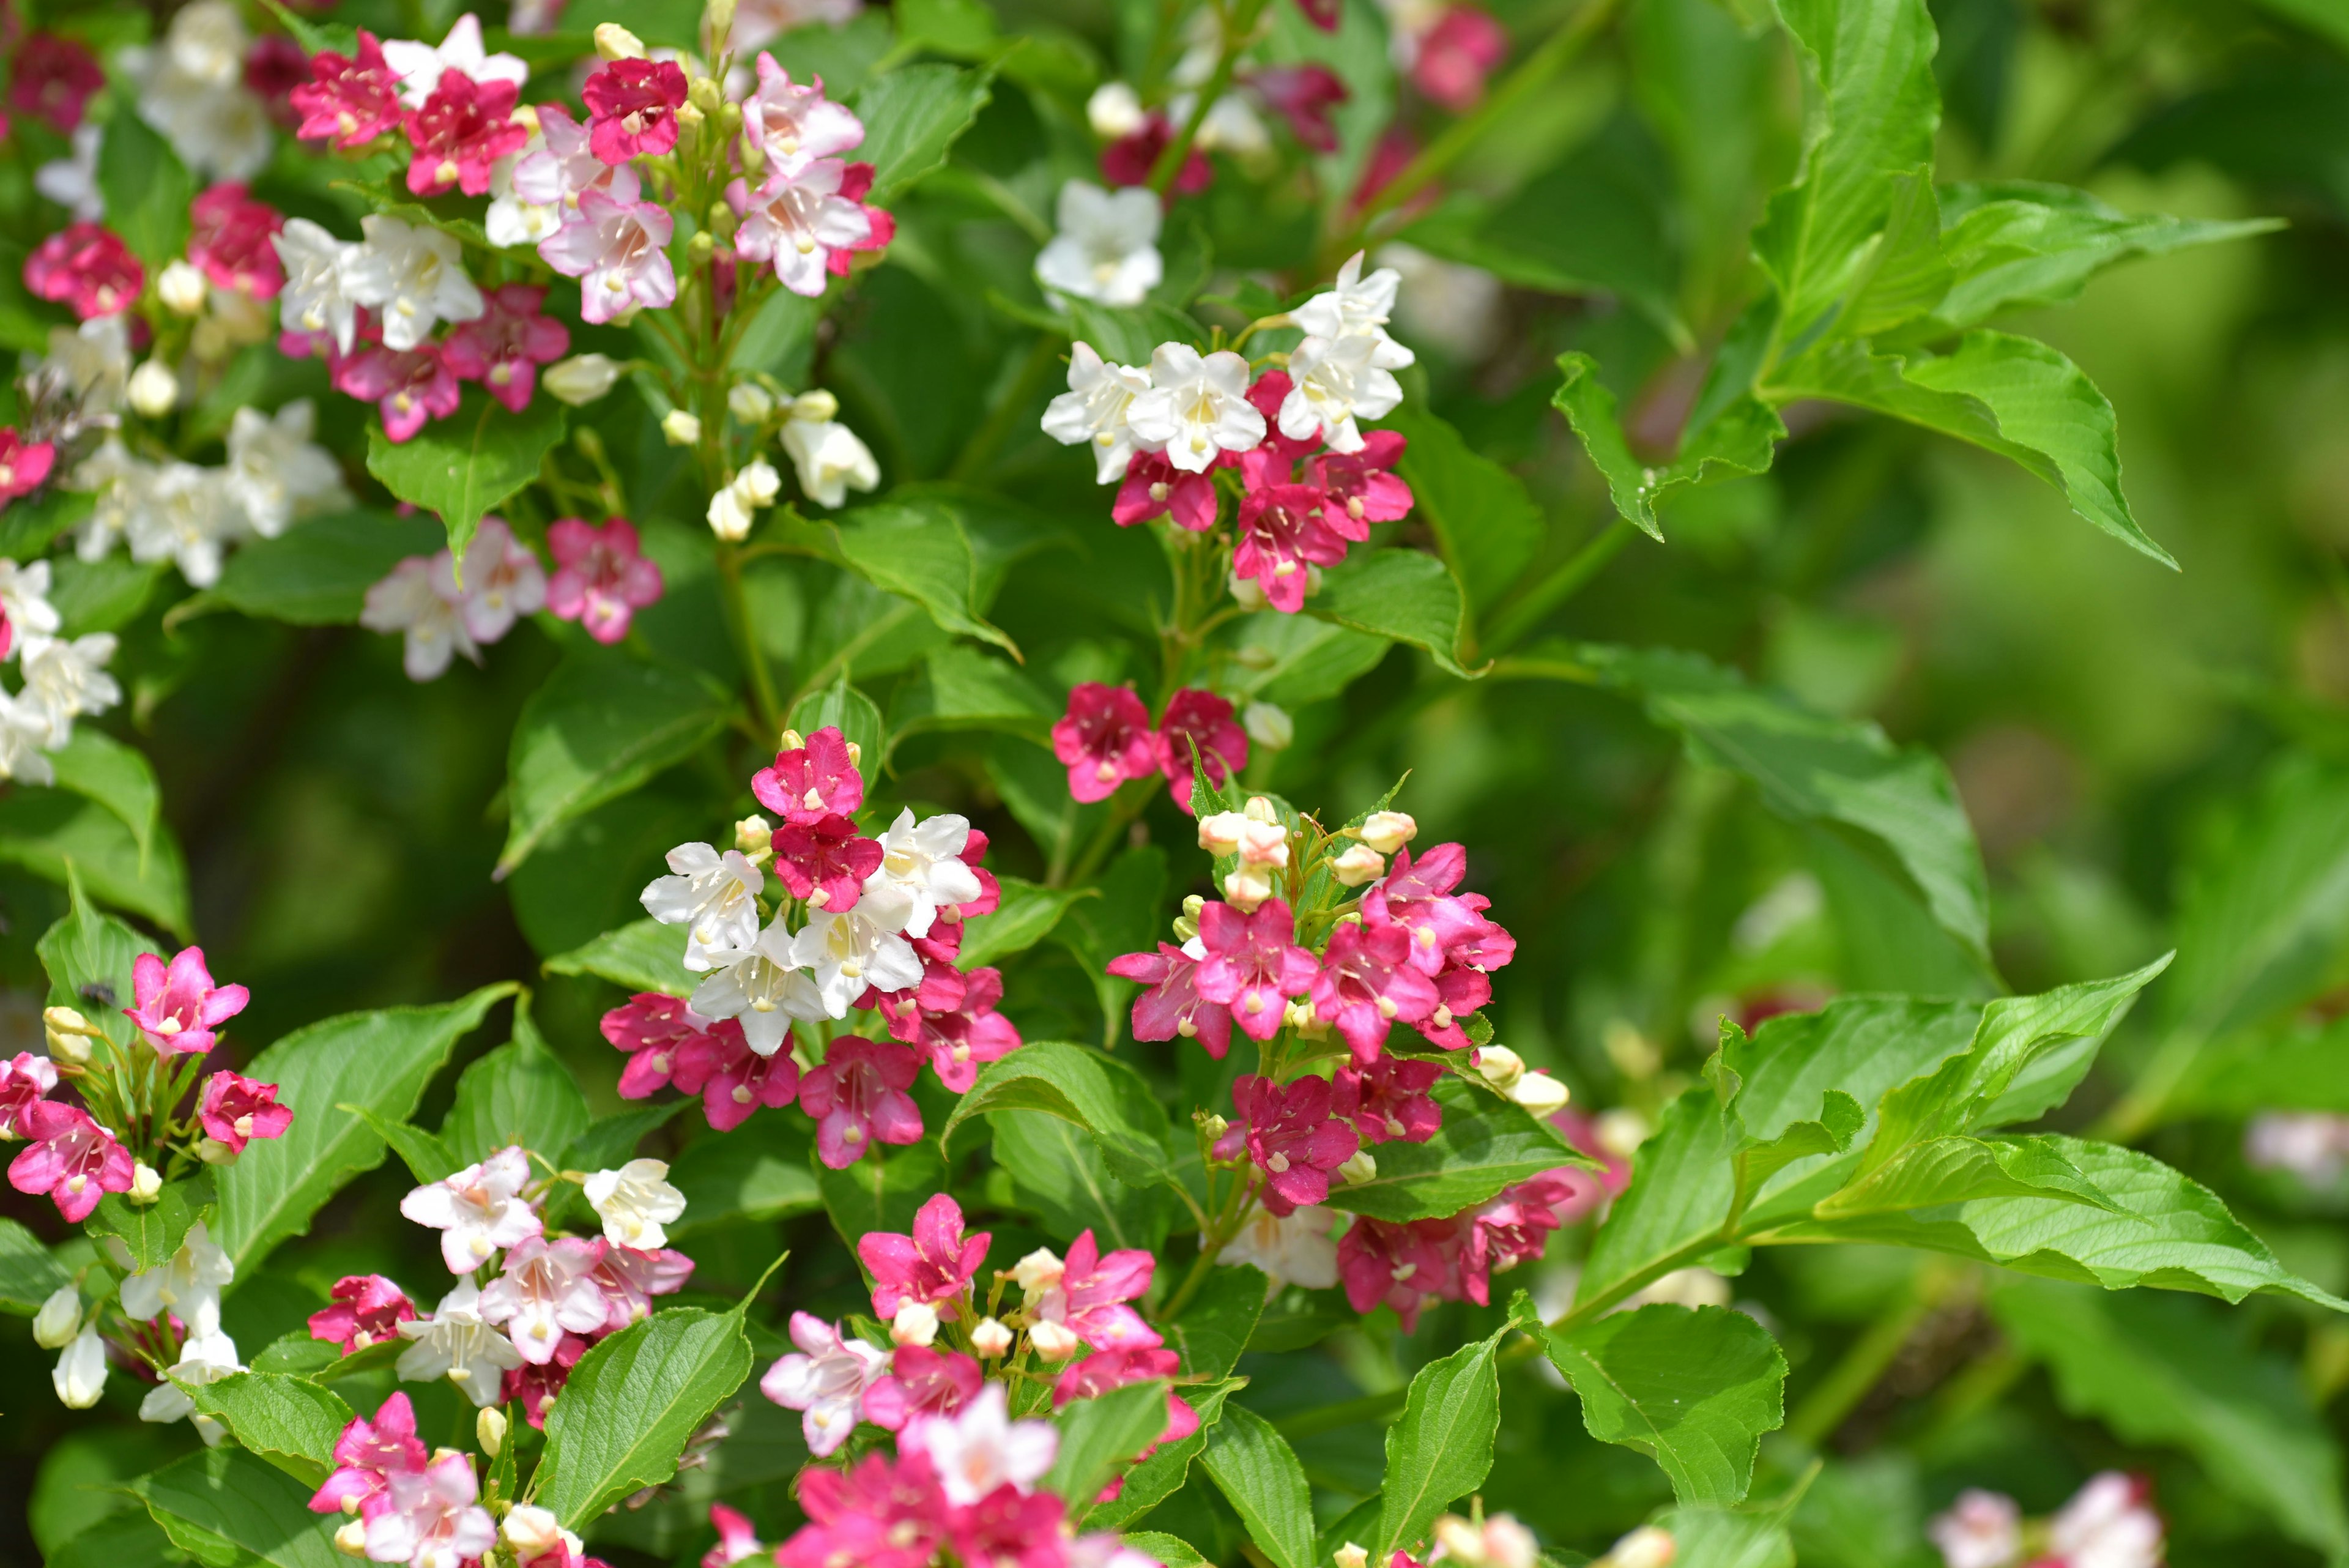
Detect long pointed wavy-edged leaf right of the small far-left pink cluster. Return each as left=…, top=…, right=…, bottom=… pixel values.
left=212, top=985, right=514, bottom=1274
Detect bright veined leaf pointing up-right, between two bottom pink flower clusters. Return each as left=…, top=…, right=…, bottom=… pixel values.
left=531, top=1302, right=752, bottom=1531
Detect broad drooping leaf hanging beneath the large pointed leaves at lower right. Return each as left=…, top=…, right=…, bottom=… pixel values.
left=1527, top=1302, right=1785, bottom=1502
